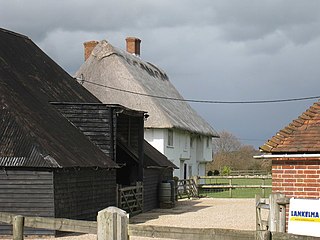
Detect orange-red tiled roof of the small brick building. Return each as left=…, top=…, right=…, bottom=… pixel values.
left=260, top=102, right=320, bottom=153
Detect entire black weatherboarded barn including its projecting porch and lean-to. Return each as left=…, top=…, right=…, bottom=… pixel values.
left=0, top=29, right=176, bottom=235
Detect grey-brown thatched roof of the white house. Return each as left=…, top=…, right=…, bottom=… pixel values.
left=76, top=40, right=218, bottom=136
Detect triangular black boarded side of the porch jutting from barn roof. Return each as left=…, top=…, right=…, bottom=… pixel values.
left=54, top=104, right=115, bottom=159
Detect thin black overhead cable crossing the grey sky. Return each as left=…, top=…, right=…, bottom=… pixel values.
left=76, top=78, right=320, bottom=104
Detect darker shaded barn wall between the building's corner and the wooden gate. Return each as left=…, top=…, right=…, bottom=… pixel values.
left=54, top=168, right=116, bottom=220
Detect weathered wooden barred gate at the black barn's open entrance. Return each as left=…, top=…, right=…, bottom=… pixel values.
left=118, top=182, right=143, bottom=216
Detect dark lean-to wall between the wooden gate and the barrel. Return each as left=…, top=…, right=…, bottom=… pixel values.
left=143, top=168, right=173, bottom=212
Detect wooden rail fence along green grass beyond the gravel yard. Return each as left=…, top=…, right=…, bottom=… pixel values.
left=196, top=175, right=272, bottom=198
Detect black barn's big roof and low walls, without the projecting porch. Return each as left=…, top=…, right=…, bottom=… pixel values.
left=0, top=29, right=117, bottom=234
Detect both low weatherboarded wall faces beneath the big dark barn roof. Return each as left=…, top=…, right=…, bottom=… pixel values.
left=0, top=168, right=116, bottom=235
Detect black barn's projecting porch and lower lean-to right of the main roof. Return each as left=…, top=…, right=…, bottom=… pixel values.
left=52, top=102, right=177, bottom=212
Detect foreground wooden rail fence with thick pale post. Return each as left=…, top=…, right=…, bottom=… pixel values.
left=0, top=194, right=318, bottom=240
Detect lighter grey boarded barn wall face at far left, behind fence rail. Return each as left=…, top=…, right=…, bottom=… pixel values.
left=0, top=170, right=54, bottom=235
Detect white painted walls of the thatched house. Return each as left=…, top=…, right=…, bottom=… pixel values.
left=144, top=129, right=212, bottom=179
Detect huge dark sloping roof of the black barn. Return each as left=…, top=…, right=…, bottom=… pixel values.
left=0, top=29, right=116, bottom=168
